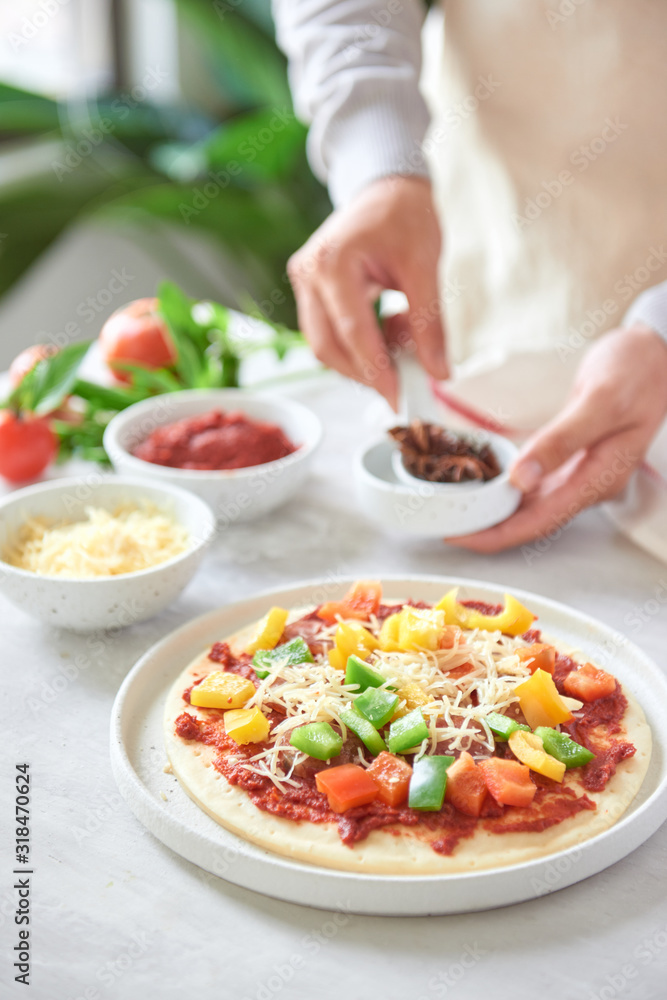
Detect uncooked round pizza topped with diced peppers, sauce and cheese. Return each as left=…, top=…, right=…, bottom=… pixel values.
left=165, top=581, right=651, bottom=875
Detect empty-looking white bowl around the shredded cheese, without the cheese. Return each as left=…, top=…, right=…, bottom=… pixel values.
left=0, top=473, right=215, bottom=632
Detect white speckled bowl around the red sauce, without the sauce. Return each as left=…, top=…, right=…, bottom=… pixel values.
left=104, top=389, right=322, bottom=528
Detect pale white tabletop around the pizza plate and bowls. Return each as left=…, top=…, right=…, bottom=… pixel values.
left=0, top=376, right=667, bottom=1000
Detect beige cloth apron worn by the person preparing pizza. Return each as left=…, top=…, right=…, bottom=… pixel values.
left=424, top=0, right=667, bottom=557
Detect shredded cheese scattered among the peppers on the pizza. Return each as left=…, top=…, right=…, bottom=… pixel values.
left=241, top=617, right=530, bottom=791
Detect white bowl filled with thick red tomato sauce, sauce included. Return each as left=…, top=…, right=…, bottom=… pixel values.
left=104, top=389, right=322, bottom=529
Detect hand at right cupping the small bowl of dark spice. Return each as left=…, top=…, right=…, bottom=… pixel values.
left=448, top=324, right=667, bottom=552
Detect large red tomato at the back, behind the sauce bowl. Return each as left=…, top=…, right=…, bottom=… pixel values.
left=99, top=299, right=176, bottom=382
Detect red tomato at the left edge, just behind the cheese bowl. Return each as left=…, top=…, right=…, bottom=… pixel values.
left=0, top=410, right=58, bottom=483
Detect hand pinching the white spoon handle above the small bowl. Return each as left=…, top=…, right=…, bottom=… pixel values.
left=287, top=176, right=448, bottom=408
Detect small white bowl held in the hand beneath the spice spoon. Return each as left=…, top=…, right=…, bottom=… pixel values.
left=355, top=432, right=521, bottom=538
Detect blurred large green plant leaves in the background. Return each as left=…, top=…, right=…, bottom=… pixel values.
left=0, top=0, right=329, bottom=325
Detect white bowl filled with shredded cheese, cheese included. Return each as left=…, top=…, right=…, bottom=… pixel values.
left=0, top=476, right=215, bottom=632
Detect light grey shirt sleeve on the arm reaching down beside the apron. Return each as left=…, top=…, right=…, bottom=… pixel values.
left=273, top=0, right=429, bottom=206
